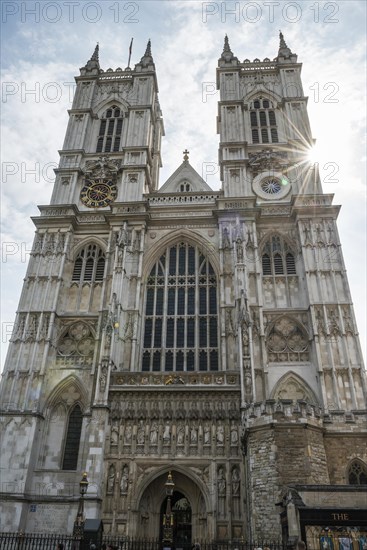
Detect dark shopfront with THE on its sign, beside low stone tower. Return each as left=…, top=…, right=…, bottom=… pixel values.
left=298, top=508, right=367, bottom=550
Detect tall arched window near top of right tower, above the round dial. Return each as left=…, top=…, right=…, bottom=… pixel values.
left=250, top=98, right=279, bottom=143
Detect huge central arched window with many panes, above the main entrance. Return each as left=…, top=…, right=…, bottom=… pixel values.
left=142, top=242, right=218, bottom=371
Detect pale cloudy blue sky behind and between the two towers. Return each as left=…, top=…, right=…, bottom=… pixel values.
left=0, top=0, right=367, bottom=370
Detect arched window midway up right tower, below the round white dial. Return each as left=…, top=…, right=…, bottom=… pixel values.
left=262, top=235, right=296, bottom=276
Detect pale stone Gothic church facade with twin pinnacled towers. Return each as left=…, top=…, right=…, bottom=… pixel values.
left=1, top=35, right=367, bottom=548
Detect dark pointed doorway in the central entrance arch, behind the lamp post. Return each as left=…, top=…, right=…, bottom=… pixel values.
left=159, top=491, right=192, bottom=550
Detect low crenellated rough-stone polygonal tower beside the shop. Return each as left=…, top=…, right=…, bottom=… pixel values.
left=243, top=400, right=329, bottom=539
